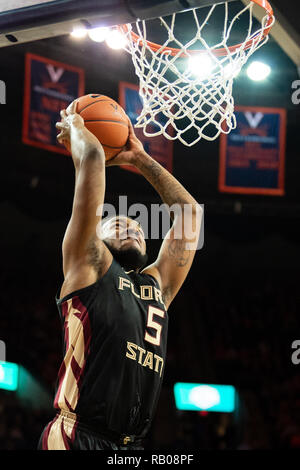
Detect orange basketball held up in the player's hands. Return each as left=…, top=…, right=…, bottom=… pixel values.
left=76, top=94, right=129, bottom=160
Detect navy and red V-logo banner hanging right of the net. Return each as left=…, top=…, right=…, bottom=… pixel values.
left=219, top=106, right=286, bottom=196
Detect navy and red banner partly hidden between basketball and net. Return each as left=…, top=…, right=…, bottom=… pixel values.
left=119, top=82, right=173, bottom=173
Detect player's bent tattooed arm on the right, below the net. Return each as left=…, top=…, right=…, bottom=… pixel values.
left=106, top=120, right=202, bottom=308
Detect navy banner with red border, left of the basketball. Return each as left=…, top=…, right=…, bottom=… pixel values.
left=22, top=53, right=84, bottom=155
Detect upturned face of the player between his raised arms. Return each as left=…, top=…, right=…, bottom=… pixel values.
left=102, top=216, right=146, bottom=255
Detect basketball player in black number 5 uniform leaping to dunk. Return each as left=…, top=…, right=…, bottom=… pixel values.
left=39, top=101, right=201, bottom=450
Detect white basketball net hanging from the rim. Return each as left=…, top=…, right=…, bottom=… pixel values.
left=120, top=1, right=274, bottom=146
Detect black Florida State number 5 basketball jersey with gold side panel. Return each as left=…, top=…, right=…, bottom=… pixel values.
left=54, top=260, right=168, bottom=437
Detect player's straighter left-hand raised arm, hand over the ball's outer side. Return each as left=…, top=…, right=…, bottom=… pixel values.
left=56, top=101, right=111, bottom=296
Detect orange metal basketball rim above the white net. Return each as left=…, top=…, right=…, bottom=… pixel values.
left=119, top=0, right=274, bottom=57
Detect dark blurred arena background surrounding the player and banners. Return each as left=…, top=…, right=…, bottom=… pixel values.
left=0, top=0, right=300, bottom=450
